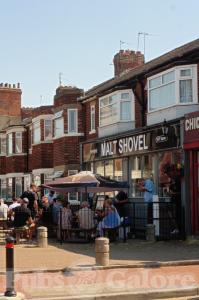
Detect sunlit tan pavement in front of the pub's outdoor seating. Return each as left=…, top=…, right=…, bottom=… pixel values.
left=0, top=240, right=199, bottom=300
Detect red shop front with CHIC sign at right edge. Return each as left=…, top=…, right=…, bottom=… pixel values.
left=183, top=112, right=199, bottom=235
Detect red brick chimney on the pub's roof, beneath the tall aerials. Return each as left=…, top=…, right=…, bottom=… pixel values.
left=113, top=50, right=144, bottom=76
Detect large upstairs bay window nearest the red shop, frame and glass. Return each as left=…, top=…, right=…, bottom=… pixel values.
left=148, top=65, right=197, bottom=112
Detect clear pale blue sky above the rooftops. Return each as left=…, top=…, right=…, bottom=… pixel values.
left=0, top=0, right=199, bottom=106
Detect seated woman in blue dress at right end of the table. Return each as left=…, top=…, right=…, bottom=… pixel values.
left=97, top=199, right=121, bottom=236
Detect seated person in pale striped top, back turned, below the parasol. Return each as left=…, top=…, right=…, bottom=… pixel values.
left=77, top=201, right=95, bottom=229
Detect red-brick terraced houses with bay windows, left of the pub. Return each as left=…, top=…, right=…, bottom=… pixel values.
left=0, top=84, right=84, bottom=200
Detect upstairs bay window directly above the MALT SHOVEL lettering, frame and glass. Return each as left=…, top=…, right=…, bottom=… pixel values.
left=99, top=90, right=134, bottom=126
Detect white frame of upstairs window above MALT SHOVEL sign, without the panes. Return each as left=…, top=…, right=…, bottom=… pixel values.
left=99, top=89, right=135, bottom=127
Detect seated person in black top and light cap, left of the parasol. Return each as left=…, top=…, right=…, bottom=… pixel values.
left=13, top=198, right=35, bottom=239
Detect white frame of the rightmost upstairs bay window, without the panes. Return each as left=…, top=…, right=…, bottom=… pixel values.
left=147, top=64, right=198, bottom=113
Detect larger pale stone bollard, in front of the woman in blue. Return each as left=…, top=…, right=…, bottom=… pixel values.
left=95, top=237, right=109, bottom=266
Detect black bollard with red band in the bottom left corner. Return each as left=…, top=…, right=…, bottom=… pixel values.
left=4, top=236, right=17, bottom=297
